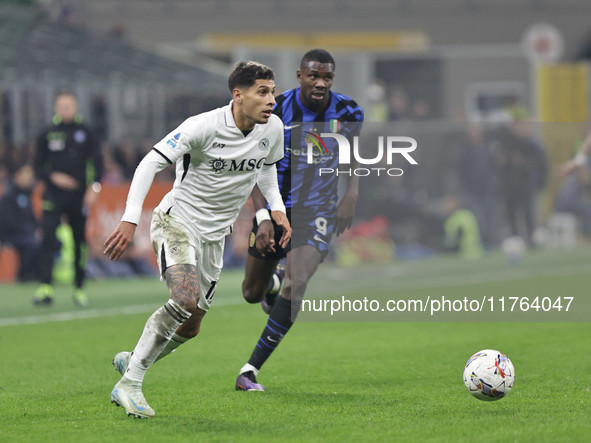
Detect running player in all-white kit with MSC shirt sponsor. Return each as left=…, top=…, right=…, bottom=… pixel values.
left=105, top=62, right=291, bottom=418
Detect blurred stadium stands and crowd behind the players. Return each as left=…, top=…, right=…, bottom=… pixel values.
left=0, top=0, right=591, bottom=281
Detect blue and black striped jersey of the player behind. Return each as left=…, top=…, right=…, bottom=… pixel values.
left=273, top=87, right=364, bottom=212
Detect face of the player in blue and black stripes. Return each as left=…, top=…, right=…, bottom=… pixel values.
left=297, top=61, right=334, bottom=111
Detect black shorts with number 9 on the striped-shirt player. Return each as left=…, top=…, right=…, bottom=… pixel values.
left=248, top=208, right=335, bottom=261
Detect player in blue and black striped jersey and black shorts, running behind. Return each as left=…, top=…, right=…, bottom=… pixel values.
left=236, top=49, right=363, bottom=391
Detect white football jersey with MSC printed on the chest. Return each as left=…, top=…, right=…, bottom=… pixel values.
left=154, top=101, right=283, bottom=241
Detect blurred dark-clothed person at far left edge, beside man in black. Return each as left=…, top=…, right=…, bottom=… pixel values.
left=0, top=165, right=41, bottom=281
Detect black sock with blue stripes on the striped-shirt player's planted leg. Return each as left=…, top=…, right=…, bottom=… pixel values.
left=248, top=297, right=293, bottom=369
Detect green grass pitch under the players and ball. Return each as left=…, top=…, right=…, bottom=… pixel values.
left=0, top=249, right=591, bottom=443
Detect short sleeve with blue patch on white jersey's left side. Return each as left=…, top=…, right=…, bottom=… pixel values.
left=154, top=115, right=207, bottom=164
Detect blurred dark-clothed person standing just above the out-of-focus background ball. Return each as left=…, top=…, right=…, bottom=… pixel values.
left=458, top=124, right=499, bottom=247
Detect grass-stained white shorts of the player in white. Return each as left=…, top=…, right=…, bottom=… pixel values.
left=150, top=209, right=225, bottom=311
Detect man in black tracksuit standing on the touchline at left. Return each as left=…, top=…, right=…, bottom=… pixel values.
left=33, top=93, right=103, bottom=307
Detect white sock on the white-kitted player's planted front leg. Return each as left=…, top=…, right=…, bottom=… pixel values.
left=124, top=300, right=191, bottom=383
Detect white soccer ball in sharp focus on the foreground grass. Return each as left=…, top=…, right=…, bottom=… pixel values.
left=464, top=349, right=515, bottom=401
